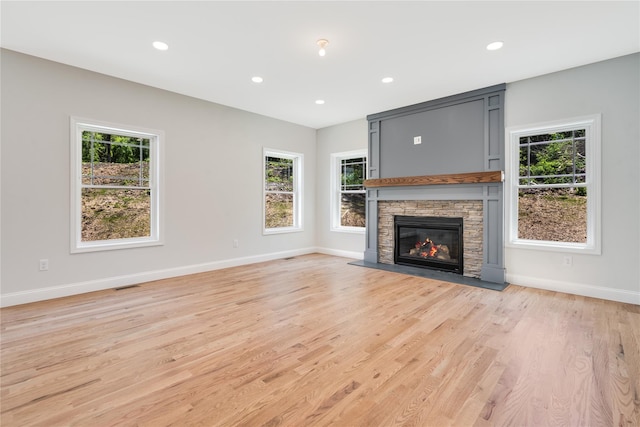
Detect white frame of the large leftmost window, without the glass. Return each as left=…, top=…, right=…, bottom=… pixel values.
left=69, top=116, right=164, bottom=253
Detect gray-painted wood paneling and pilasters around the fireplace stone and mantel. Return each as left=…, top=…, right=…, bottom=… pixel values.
left=364, top=84, right=506, bottom=283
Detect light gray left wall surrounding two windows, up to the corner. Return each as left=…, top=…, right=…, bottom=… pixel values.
left=1, top=50, right=316, bottom=304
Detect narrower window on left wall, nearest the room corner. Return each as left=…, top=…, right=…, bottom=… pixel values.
left=263, top=149, right=303, bottom=234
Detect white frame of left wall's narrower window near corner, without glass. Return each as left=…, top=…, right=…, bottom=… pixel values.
left=262, top=148, right=304, bottom=235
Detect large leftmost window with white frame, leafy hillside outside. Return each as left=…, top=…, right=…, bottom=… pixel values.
left=71, top=117, right=162, bottom=252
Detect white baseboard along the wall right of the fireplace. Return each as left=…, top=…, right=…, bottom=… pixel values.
left=507, top=273, right=640, bottom=305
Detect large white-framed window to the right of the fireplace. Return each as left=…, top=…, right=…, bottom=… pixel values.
left=507, top=115, right=600, bottom=254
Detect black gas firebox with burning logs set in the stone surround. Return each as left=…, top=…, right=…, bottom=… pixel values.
left=393, top=215, right=464, bottom=274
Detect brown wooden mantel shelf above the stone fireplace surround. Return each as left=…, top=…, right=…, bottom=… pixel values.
left=364, top=171, right=504, bottom=188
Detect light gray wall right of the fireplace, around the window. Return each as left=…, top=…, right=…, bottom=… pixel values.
left=505, top=54, right=640, bottom=304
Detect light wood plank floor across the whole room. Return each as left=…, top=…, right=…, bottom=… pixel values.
left=1, top=255, right=640, bottom=427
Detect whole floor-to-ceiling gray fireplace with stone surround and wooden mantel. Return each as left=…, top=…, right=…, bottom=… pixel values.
left=364, top=84, right=506, bottom=284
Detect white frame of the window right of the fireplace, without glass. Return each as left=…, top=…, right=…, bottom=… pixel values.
left=505, top=114, right=602, bottom=255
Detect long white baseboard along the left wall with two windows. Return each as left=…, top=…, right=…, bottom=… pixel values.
left=0, top=248, right=319, bottom=307
